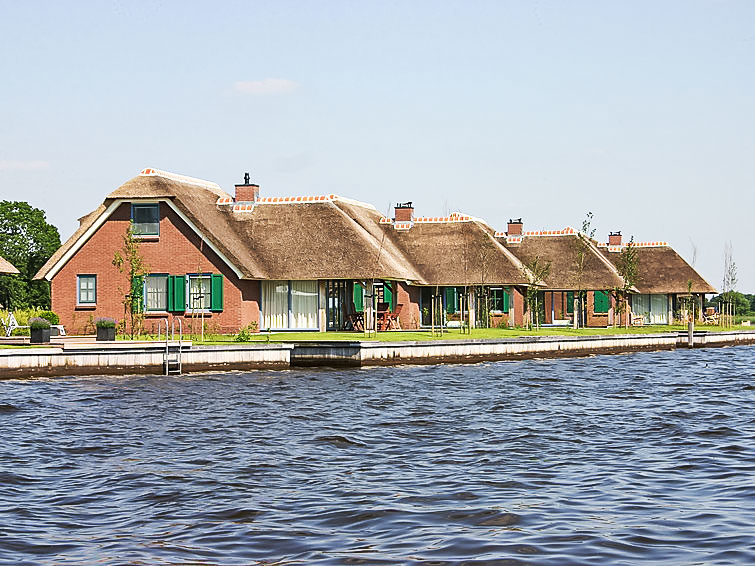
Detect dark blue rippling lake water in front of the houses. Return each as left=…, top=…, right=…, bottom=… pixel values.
left=0, top=347, right=755, bottom=566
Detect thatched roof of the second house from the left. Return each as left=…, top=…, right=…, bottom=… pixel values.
left=383, top=217, right=529, bottom=285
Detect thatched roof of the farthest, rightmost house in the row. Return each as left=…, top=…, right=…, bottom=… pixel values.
left=602, top=244, right=717, bottom=294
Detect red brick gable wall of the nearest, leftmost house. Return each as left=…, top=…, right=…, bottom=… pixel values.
left=52, top=203, right=260, bottom=334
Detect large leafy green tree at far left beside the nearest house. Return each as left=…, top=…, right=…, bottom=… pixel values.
left=0, top=200, right=60, bottom=309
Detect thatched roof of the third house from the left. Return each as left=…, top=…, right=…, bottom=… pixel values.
left=499, top=230, right=623, bottom=291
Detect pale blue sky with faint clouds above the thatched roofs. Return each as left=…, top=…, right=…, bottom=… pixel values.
left=0, top=0, right=755, bottom=292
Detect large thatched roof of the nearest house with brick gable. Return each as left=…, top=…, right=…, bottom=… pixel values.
left=36, top=172, right=420, bottom=281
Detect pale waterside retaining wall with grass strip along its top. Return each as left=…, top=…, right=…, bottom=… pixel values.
left=0, top=327, right=755, bottom=379
